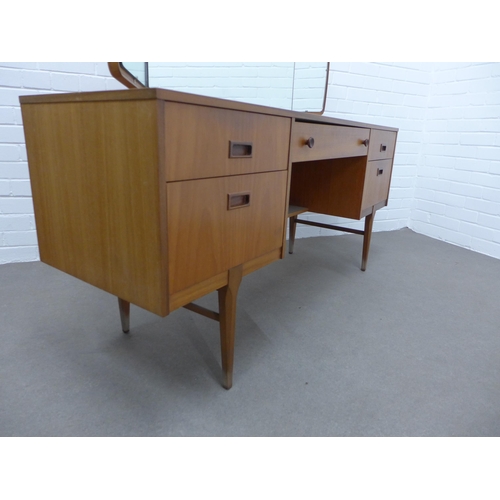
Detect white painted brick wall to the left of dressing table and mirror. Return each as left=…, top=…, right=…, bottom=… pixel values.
left=0, top=62, right=123, bottom=264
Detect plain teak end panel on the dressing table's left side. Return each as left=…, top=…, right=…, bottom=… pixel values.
left=22, top=100, right=167, bottom=315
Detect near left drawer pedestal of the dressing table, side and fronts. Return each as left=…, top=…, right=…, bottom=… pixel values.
left=22, top=91, right=291, bottom=316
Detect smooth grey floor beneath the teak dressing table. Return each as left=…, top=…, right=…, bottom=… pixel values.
left=0, top=230, right=500, bottom=437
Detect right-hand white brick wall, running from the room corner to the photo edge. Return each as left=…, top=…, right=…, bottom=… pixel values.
left=409, top=63, right=500, bottom=258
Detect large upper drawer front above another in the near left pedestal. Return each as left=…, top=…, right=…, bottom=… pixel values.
left=165, top=102, right=291, bottom=181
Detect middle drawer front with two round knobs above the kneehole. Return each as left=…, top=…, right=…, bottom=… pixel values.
left=290, top=122, right=370, bottom=162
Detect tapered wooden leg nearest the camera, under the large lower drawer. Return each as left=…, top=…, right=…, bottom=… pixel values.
left=218, top=266, right=243, bottom=389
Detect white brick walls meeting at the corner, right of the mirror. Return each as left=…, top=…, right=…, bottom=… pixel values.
left=297, top=63, right=500, bottom=258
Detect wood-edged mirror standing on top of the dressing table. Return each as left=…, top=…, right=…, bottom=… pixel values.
left=115, top=62, right=330, bottom=115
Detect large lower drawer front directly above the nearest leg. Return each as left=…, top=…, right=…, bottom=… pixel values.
left=167, top=171, right=287, bottom=294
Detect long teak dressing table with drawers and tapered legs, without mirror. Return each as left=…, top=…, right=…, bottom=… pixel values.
left=20, top=78, right=397, bottom=389
